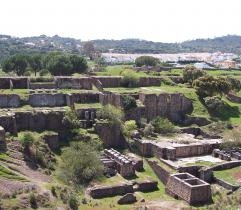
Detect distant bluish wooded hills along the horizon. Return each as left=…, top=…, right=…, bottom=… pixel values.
left=0, top=35, right=241, bottom=61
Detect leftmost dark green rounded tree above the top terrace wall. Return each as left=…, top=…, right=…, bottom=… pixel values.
left=2, top=54, right=28, bottom=76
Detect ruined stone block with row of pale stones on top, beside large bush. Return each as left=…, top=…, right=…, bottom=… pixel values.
left=102, top=149, right=135, bottom=177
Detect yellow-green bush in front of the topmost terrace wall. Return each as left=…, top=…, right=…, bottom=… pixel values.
left=121, top=70, right=140, bottom=88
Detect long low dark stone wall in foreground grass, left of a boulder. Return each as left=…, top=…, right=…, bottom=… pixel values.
left=89, top=184, right=134, bottom=199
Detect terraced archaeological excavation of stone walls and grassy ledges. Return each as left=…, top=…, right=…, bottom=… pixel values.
left=0, top=76, right=241, bottom=210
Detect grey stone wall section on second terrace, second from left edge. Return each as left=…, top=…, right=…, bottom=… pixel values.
left=28, top=93, right=67, bottom=107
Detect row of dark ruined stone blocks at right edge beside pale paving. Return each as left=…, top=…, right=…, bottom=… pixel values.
left=212, top=148, right=241, bottom=161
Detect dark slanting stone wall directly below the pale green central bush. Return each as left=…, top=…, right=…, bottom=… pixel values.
left=95, top=122, right=126, bottom=148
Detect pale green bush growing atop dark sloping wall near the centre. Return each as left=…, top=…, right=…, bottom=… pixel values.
left=96, top=104, right=124, bottom=126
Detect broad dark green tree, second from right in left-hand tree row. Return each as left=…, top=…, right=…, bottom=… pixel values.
left=46, top=55, right=73, bottom=75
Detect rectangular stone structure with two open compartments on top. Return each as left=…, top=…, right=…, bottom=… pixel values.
left=166, top=173, right=212, bottom=205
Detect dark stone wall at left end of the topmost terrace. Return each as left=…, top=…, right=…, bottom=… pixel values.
left=0, top=77, right=28, bottom=89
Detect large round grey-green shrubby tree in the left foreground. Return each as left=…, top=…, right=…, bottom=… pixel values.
left=59, top=142, right=103, bottom=185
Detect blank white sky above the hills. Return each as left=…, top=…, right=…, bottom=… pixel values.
left=0, top=0, right=241, bottom=42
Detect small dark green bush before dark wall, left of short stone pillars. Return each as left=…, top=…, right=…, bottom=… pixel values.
left=62, top=110, right=80, bottom=129
